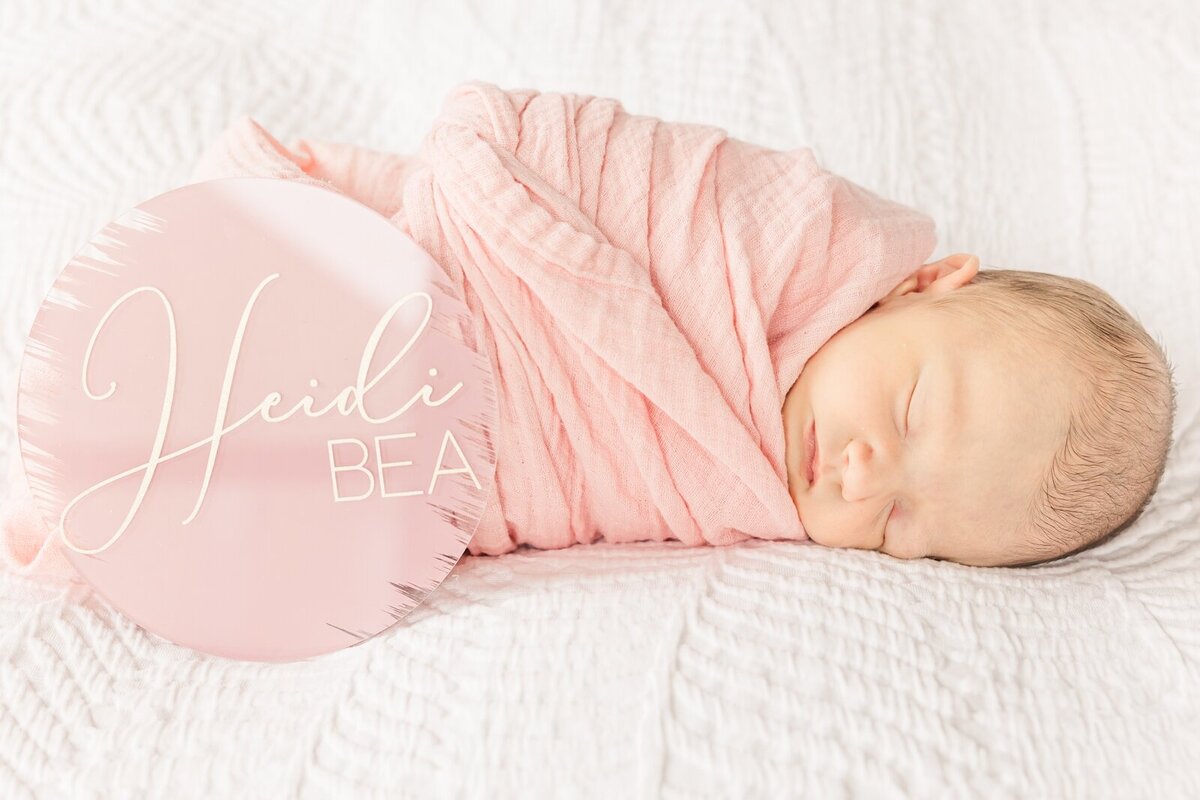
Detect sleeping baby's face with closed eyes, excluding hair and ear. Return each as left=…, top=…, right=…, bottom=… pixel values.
left=782, top=284, right=1069, bottom=566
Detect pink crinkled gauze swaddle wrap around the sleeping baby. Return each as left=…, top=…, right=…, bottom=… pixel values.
left=2, top=82, right=935, bottom=582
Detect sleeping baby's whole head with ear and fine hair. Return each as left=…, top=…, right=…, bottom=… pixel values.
left=782, top=253, right=1176, bottom=566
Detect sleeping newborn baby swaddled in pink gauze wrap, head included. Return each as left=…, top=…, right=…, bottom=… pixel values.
left=2, top=82, right=1175, bottom=582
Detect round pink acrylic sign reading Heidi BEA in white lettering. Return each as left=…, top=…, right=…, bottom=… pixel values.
left=18, top=178, right=497, bottom=661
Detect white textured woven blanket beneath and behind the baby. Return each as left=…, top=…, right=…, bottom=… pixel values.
left=0, top=0, right=1200, bottom=798
